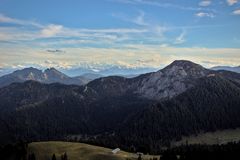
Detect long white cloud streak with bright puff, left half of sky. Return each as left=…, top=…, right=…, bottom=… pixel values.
left=0, top=24, right=146, bottom=44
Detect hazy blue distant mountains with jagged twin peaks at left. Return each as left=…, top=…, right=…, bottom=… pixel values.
left=0, top=67, right=156, bottom=87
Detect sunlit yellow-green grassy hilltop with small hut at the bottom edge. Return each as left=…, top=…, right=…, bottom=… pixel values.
left=28, top=141, right=159, bottom=160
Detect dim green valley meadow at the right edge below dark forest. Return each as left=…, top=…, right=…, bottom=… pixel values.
left=172, top=128, right=240, bottom=146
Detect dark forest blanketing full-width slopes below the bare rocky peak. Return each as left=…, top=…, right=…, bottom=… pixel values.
left=0, top=77, right=240, bottom=154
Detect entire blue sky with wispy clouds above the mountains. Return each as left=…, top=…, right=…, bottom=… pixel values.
left=0, top=0, right=240, bottom=69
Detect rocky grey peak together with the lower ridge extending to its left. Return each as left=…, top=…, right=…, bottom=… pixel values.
left=84, top=60, right=211, bottom=100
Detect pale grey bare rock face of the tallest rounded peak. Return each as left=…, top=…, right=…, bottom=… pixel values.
left=136, top=60, right=209, bottom=100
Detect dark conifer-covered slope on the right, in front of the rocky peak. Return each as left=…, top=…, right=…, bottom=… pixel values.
left=76, top=78, right=240, bottom=154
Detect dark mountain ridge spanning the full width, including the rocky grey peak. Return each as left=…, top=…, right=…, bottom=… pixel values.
left=0, top=60, right=240, bottom=153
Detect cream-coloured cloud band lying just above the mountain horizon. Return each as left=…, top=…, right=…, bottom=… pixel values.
left=0, top=44, right=240, bottom=68
